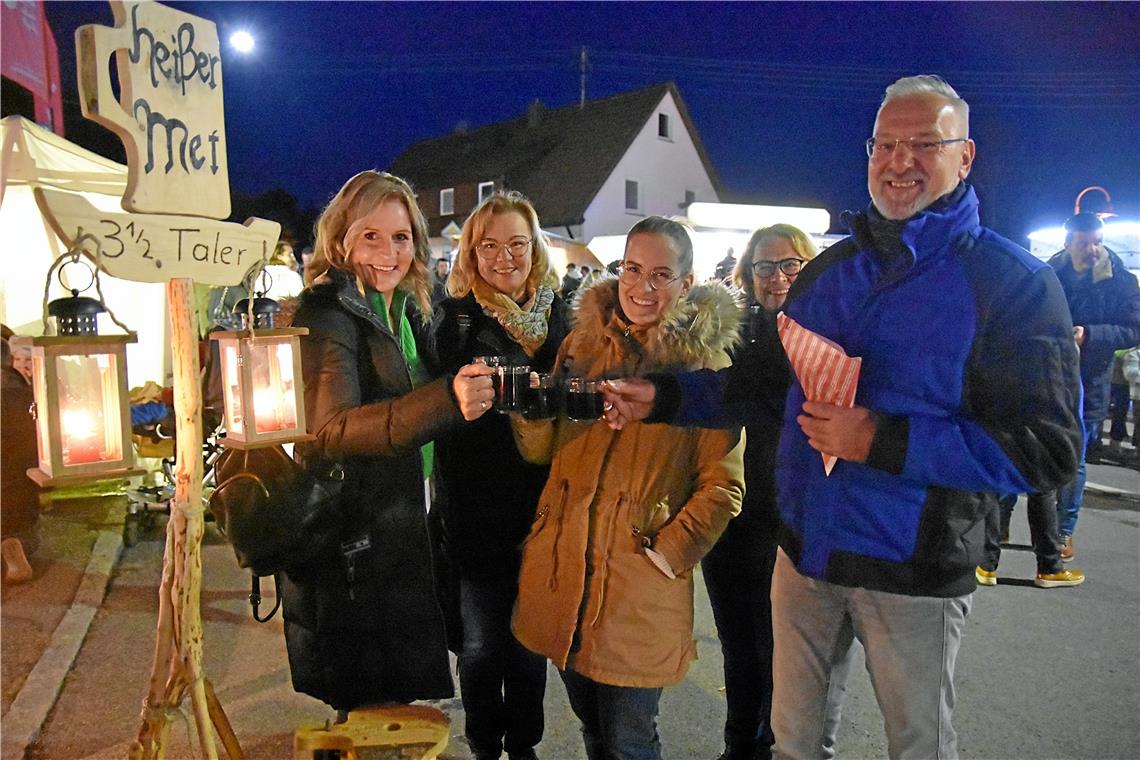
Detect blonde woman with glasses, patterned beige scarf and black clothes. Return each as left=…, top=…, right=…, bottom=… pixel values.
left=433, top=193, right=569, bottom=760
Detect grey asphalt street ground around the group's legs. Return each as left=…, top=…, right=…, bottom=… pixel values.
left=5, top=467, right=1140, bottom=760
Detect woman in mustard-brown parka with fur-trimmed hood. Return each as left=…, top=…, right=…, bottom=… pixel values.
left=513, top=216, right=743, bottom=759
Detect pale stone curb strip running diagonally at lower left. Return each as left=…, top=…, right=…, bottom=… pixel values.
left=0, top=531, right=123, bottom=760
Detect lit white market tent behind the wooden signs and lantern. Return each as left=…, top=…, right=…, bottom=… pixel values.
left=0, top=116, right=170, bottom=386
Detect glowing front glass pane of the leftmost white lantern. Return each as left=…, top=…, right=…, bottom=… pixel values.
left=56, top=353, right=123, bottom=466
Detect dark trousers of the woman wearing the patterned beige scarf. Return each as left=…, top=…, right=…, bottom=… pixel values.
left=458, top=577, right=546, bottom=758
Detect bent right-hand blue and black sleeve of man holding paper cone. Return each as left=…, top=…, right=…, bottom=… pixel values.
left=868, top=268, right=1081, bottom=495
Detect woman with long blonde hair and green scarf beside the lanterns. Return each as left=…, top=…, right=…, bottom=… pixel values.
left=279, top=171, right=488, bottom=718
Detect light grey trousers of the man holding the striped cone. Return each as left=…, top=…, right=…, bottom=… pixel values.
left=772, top=549, right=972, bottom=760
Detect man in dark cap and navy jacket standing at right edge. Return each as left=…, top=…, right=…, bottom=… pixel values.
left=1049, top=213, right=1140, bottom=562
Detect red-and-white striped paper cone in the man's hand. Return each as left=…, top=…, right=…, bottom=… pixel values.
left=776, top=311, right=863, bottom=475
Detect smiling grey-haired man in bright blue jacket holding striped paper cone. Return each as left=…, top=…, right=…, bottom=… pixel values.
left=606, top=76, right=1081, bottom=758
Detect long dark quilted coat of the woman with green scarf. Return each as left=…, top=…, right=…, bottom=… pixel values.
left=280, top=270, right=462, bottom=709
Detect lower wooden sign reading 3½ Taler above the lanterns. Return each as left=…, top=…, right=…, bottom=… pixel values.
left=35, top=188, right=282, bottom=285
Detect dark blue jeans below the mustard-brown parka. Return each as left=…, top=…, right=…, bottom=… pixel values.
left=560, top=670, right=661, bottom=760
